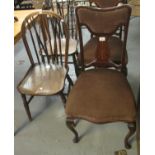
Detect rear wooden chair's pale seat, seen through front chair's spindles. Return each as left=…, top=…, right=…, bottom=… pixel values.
left=42, top=38, right=77, bottom=55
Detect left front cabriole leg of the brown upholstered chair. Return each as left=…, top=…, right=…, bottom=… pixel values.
left=66, top=118, right=79, bottom=143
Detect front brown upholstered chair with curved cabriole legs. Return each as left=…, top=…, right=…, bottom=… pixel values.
left=65, top=5, right=136, bottom=148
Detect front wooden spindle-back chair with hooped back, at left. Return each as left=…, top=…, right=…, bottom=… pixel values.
left=17, top=11, right=73, bottom=121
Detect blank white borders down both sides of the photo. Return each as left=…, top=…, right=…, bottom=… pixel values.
left=0, top=0, right=155, bottom=155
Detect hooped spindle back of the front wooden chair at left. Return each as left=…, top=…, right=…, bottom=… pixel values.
left=22, top=11, right=69, bottom=67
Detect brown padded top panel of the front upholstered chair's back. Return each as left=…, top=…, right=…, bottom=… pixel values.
left=77, top=5, right=131, bottom=35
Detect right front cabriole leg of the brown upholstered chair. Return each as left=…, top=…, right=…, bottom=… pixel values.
left=124, top=122, right=136, bottom=149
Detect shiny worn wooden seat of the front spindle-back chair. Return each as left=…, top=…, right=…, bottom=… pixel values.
left=18, top=64, right=67, bottom=95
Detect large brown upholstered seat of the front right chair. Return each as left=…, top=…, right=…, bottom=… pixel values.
left=66, top=69, right=136, bottom=123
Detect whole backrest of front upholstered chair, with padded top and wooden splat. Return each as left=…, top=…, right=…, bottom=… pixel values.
left=76, top=4, right=131, bottom=70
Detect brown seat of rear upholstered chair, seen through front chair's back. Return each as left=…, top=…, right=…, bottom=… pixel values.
left=80, top=36, right=127, bottom=64
